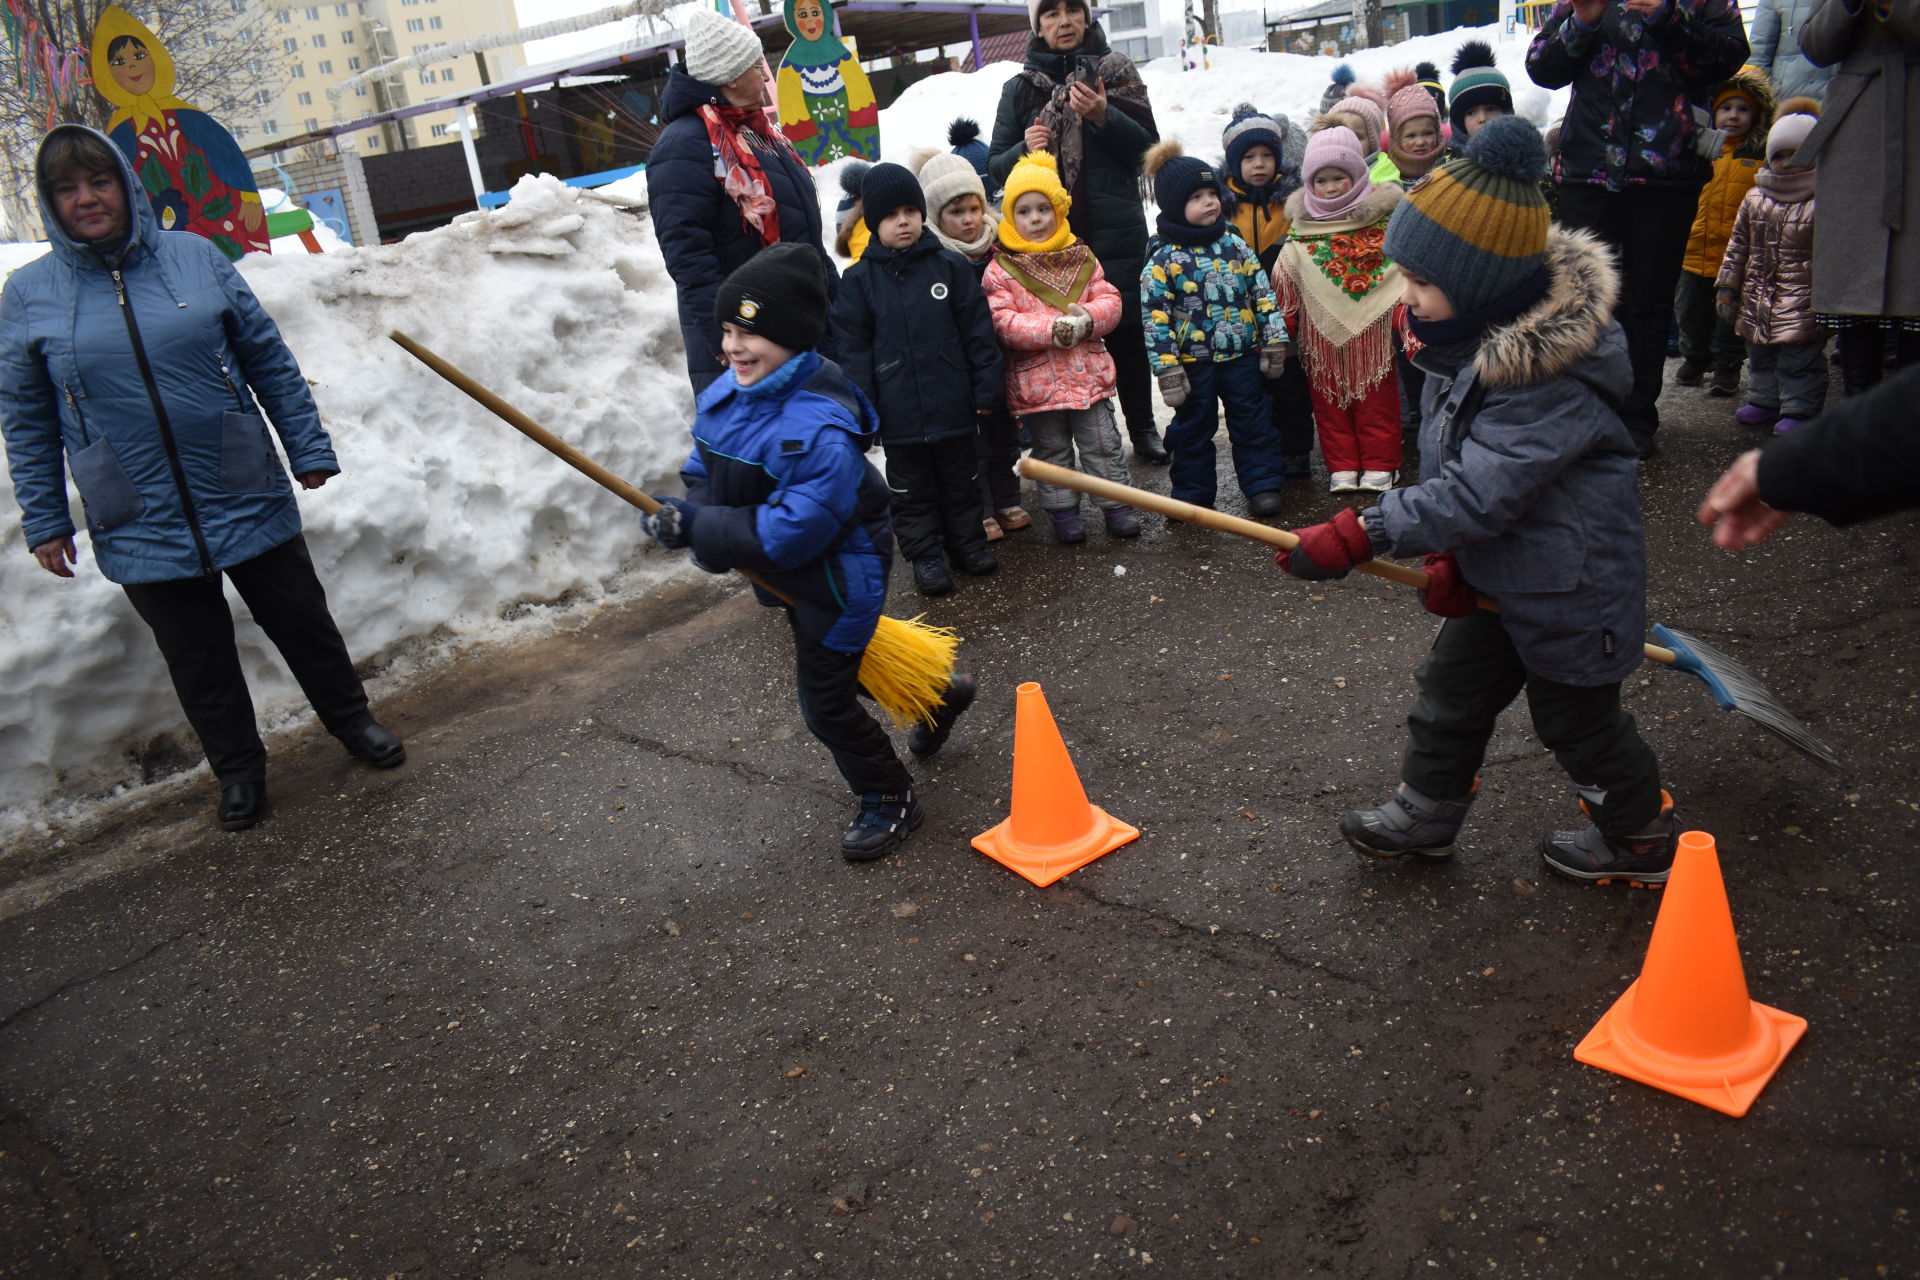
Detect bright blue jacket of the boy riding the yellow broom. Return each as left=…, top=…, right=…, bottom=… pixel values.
left=680, top=351, right=893, bottom=652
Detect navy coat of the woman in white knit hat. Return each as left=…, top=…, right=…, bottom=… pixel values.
left=647, top=67, right=839, bottom=395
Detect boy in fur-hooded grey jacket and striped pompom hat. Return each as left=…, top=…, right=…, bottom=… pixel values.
left=1277, top=117, right=1680, bottom=885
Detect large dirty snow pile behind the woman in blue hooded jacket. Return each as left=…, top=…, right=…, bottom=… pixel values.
left=0, top=178, right=693, bottom=837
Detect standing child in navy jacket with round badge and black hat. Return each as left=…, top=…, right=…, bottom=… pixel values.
left=833, top=165, right=1006, bottom=595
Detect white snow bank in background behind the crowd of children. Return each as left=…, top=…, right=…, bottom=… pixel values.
left=816, top=23, right=1567, bottom=226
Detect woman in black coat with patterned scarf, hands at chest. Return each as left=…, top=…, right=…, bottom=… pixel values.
left=987, top=0, right=1167, bottom=462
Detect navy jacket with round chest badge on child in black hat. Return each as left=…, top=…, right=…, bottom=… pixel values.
left=833, top=228, right=1006, bottom=445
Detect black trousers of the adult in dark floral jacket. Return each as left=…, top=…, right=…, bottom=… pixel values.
left=1559, top=182, right=1699, bottom=449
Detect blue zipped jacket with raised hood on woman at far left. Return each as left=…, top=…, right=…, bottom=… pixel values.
left=0, top=125, right=340, bottom=583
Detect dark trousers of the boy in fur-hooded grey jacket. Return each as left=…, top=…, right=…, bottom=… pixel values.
left=1400, top=610, right=1661, bottom=835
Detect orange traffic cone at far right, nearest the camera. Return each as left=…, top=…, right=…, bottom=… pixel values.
left=1572, top=831, right=1807, bottom=1115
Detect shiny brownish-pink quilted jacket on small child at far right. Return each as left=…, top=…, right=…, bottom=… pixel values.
left=1715, top=169, right=1824, bottom=345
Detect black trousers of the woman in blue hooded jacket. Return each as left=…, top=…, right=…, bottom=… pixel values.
left=121, top=533, right=372, bottom=787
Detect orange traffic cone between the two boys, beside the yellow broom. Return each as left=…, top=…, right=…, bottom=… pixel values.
left=973, top=679, right=1140, bottom=889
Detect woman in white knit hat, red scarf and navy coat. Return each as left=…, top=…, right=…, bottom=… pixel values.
left=647, top=10, right=839, bottom=395
